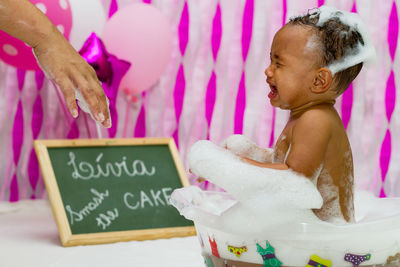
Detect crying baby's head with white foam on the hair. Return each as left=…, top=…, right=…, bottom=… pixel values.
left=265, top=6, right=374, bottom=109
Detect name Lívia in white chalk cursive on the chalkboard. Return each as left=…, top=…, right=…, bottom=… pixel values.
left=67, top=152, right=156, bottom=180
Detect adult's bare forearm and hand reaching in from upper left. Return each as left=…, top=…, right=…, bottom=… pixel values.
left=0, top=0, right=111, bottom=127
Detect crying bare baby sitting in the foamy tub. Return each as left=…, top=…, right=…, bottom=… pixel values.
left=225, top=7, right=373, bottom=222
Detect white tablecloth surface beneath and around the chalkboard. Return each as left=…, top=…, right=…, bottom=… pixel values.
left=0, top=200, right=204, bottom=267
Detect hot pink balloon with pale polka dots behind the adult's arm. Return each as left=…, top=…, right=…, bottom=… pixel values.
left=0, top=0, right=72, bottom=70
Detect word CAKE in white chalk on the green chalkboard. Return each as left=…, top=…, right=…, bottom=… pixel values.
left=124, top=187, right=172, bottom=210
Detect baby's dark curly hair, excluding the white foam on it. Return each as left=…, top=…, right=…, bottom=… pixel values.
left=288, top=11, right=364, bottom=94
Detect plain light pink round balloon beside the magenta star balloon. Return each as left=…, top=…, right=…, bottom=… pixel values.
left=102, top=4, right=172, bottom=94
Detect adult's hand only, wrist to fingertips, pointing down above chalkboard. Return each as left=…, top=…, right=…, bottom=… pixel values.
left=33, top=28, right=111, bottom=128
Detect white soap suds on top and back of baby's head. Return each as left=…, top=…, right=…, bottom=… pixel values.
left=290, top=6, right=375, bottom=75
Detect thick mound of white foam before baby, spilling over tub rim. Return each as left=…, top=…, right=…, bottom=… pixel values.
left=172, top=140, right=322, bottom=235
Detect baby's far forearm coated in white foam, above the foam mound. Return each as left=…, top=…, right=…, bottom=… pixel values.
left=222, top=134, right=274, bottom=164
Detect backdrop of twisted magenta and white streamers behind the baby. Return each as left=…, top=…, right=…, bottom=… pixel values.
left=0, top=0, right=400, bottom=201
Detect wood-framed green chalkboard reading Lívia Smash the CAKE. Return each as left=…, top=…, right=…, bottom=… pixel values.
left=34, top=138, right=195, bottom=246
